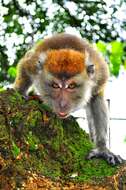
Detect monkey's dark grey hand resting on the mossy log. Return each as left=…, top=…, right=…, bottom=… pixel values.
left=87, top=148, right=124, bottom=165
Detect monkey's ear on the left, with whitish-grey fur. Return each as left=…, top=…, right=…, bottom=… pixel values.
left=37, top=52, right=47, bottom=71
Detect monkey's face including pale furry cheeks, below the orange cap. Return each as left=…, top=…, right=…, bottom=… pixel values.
left=36, top=73, right=91, bottom=118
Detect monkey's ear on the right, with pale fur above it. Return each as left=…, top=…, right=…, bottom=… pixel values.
left=85, top=52, right=95, bottom=78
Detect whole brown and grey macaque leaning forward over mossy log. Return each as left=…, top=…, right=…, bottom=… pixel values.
left=14, top=34, right=123, bottom=165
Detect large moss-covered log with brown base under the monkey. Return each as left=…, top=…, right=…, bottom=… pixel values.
left=0, top=90, right=126, bottom=190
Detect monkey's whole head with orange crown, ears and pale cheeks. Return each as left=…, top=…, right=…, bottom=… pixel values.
left=34, top=49, right=94, bottom=118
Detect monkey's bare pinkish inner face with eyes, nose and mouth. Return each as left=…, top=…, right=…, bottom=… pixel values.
left=45, top=79, right=83, bottom=118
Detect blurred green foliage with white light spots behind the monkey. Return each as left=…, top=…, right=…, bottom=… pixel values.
left=0, top=0, right=126, bottom=86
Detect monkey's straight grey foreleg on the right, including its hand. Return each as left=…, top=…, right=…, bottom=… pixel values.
left=86, top=95, right=123, bottom=165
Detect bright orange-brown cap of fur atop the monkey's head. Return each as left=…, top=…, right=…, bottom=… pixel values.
left=45, top=49, right=85, bottom=75
